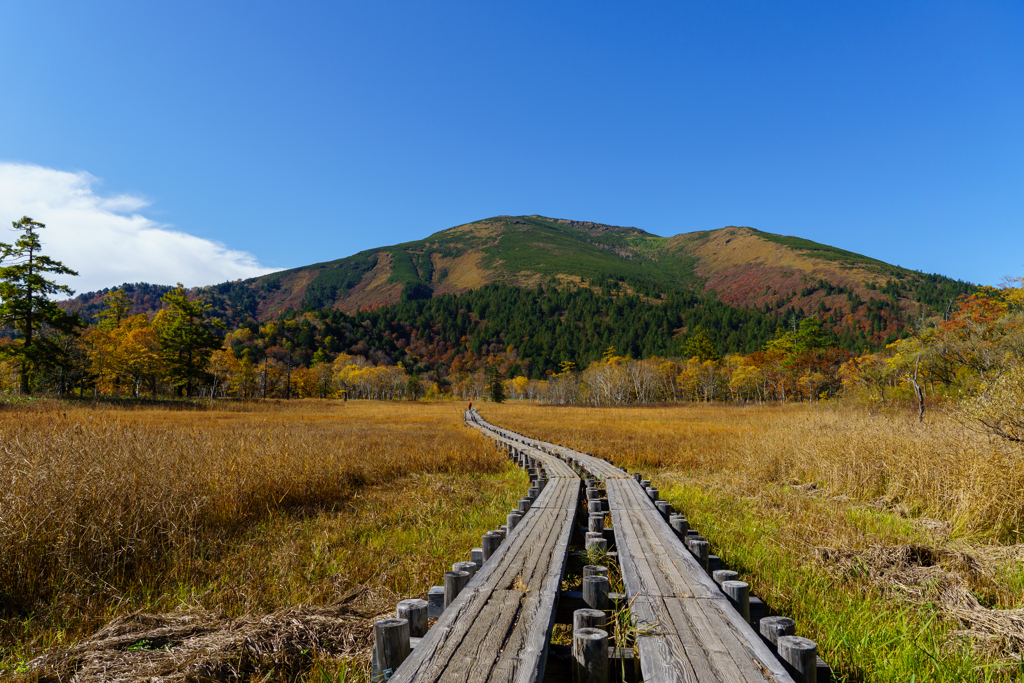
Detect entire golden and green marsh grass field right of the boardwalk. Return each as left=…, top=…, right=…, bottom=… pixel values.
left=481, top=404, right=1024, bottom=682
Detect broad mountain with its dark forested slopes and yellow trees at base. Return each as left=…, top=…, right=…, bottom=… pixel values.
left=44, top=216, right=977, bottom=400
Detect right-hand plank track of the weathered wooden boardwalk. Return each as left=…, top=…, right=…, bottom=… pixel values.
left=468, top=411, right=793, bottom=683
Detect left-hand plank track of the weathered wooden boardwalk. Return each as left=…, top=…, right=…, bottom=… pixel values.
left=390, top=413, right=581, bottom=683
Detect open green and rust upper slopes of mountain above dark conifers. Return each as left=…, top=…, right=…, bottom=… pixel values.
left=72, top=215, right=974, bottom=344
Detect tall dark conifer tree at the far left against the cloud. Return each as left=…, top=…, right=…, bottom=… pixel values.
left=0, top=216, right=82, bottom=394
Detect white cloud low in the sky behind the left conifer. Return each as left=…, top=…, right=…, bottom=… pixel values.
left=0, top=162, right=278, bottom=292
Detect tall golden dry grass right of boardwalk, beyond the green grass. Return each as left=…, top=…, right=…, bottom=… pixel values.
left=486, top=403, right=1024, bottom=541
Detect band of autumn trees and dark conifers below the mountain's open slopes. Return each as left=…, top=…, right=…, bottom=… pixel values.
left=8, top=217, right=1024, bottom=448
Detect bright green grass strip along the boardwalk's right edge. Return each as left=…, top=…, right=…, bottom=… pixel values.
left=662, top=484, right=1021, bottom=683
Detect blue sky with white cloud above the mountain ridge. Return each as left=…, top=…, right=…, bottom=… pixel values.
left=0, top=0, right=1024, bottom=291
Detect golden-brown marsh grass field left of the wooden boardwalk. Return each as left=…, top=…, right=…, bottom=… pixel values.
left=0, top=401, right=525, bottom=669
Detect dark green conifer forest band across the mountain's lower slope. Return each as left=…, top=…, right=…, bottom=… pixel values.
left=227, top=285, right=781, bottom=379
